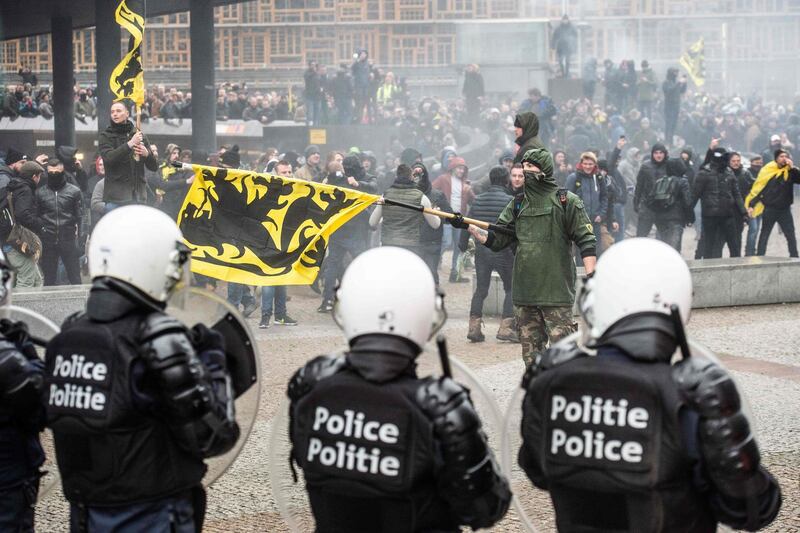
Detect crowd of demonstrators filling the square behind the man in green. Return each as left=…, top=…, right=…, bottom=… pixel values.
left=6, top=62, right=800, bottom=341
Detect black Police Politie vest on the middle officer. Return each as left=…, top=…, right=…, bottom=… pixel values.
left=292, top=365, right=458, bottom=532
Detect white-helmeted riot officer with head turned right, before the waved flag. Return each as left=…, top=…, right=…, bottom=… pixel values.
left=44, top=206, right=239, bottom=532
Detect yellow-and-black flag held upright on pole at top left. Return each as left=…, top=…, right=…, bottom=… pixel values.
left=108, top=0, right=144, bottom=106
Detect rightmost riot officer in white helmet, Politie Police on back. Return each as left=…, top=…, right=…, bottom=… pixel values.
left=519, top=238, right=781, bottom=532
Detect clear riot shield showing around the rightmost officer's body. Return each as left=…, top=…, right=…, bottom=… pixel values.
left=501, top=331, right=755, bottom=533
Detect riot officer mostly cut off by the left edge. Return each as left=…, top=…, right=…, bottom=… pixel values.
left=0, top=252, right=44, bottom=532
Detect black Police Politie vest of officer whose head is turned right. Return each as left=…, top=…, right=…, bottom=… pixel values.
left=45, top=308, right=206, bottom=506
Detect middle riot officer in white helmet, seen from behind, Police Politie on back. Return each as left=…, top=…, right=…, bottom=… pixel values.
left=288, top=246, right=511, bottom=533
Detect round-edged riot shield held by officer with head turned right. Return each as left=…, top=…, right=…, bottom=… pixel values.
left=166, top=287, right=261, bottom=486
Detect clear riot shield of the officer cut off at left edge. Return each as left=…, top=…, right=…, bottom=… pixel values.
left=0, top=305, right=60, bottom=500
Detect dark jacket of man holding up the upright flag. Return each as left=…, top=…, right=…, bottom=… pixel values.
left=97, top=121, right=158, bottom=204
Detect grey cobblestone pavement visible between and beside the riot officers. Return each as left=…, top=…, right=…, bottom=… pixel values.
left=37, top=251, right=800, bottom=532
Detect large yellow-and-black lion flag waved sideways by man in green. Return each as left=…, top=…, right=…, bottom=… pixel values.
left=178, top=165, right=379, bottom=285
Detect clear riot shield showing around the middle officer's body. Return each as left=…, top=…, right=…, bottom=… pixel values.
left=269, top=345, right=505, bottom=532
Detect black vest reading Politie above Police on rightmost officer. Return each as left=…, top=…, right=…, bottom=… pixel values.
left=519, top=354, right=716, bottom=532
